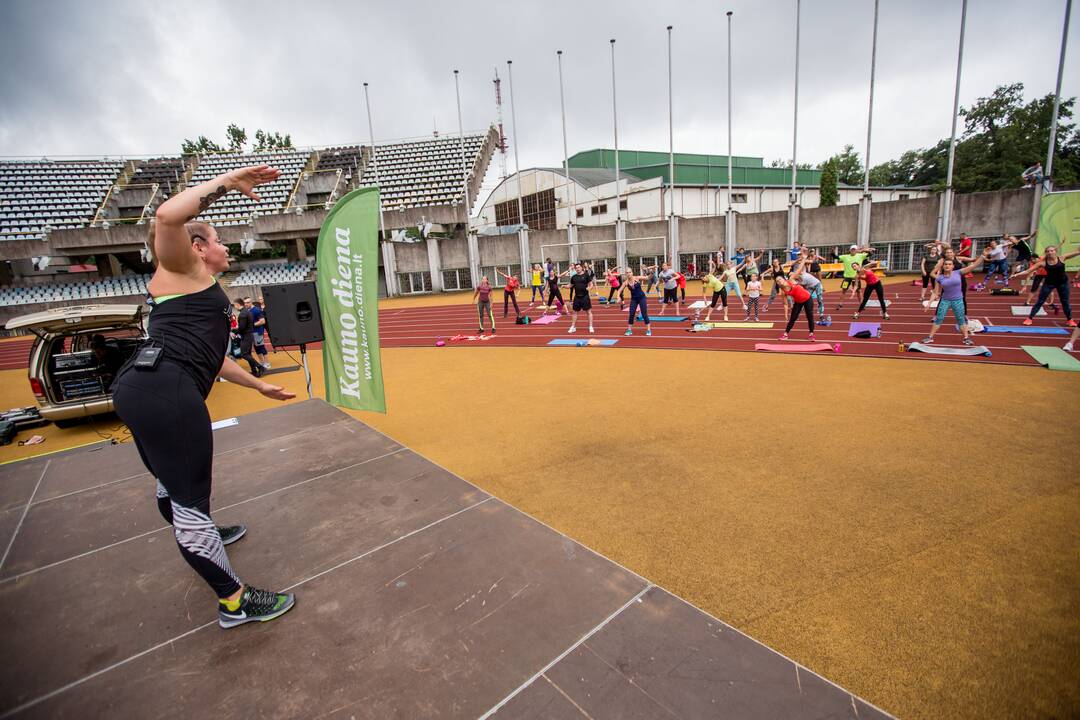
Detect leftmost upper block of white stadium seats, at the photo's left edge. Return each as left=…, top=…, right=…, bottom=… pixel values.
left=0, top=160, right=123, bottom=240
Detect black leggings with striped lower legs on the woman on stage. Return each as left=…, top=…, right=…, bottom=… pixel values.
left=113, top=359, right=240, bottom=598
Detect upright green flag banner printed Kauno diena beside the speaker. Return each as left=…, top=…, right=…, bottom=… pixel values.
left=315, top=187, right=387, bottom=412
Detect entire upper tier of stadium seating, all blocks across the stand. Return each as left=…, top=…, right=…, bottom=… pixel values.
left=0, top=129, right=487, bottom=241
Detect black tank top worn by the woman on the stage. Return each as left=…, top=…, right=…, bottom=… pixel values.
left=147, top=283, right=231, bottom=397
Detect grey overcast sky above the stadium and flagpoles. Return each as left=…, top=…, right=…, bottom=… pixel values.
left=0, top=0, right=1080, bottom=197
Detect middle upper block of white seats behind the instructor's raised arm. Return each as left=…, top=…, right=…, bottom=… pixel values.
left=188, top=150, right=311, bottom=226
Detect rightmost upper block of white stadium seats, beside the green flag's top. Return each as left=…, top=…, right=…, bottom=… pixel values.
left=363, top=134, right=487, bottom=209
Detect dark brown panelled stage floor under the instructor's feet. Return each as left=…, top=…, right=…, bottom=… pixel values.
left=0, top=400, right=890, bottom=720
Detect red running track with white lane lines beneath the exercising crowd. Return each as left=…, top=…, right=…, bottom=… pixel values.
left=0, top=283, right=1067, bottom=369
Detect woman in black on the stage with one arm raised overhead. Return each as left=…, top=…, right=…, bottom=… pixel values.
left=112, top=165, right=295, bottom=627
